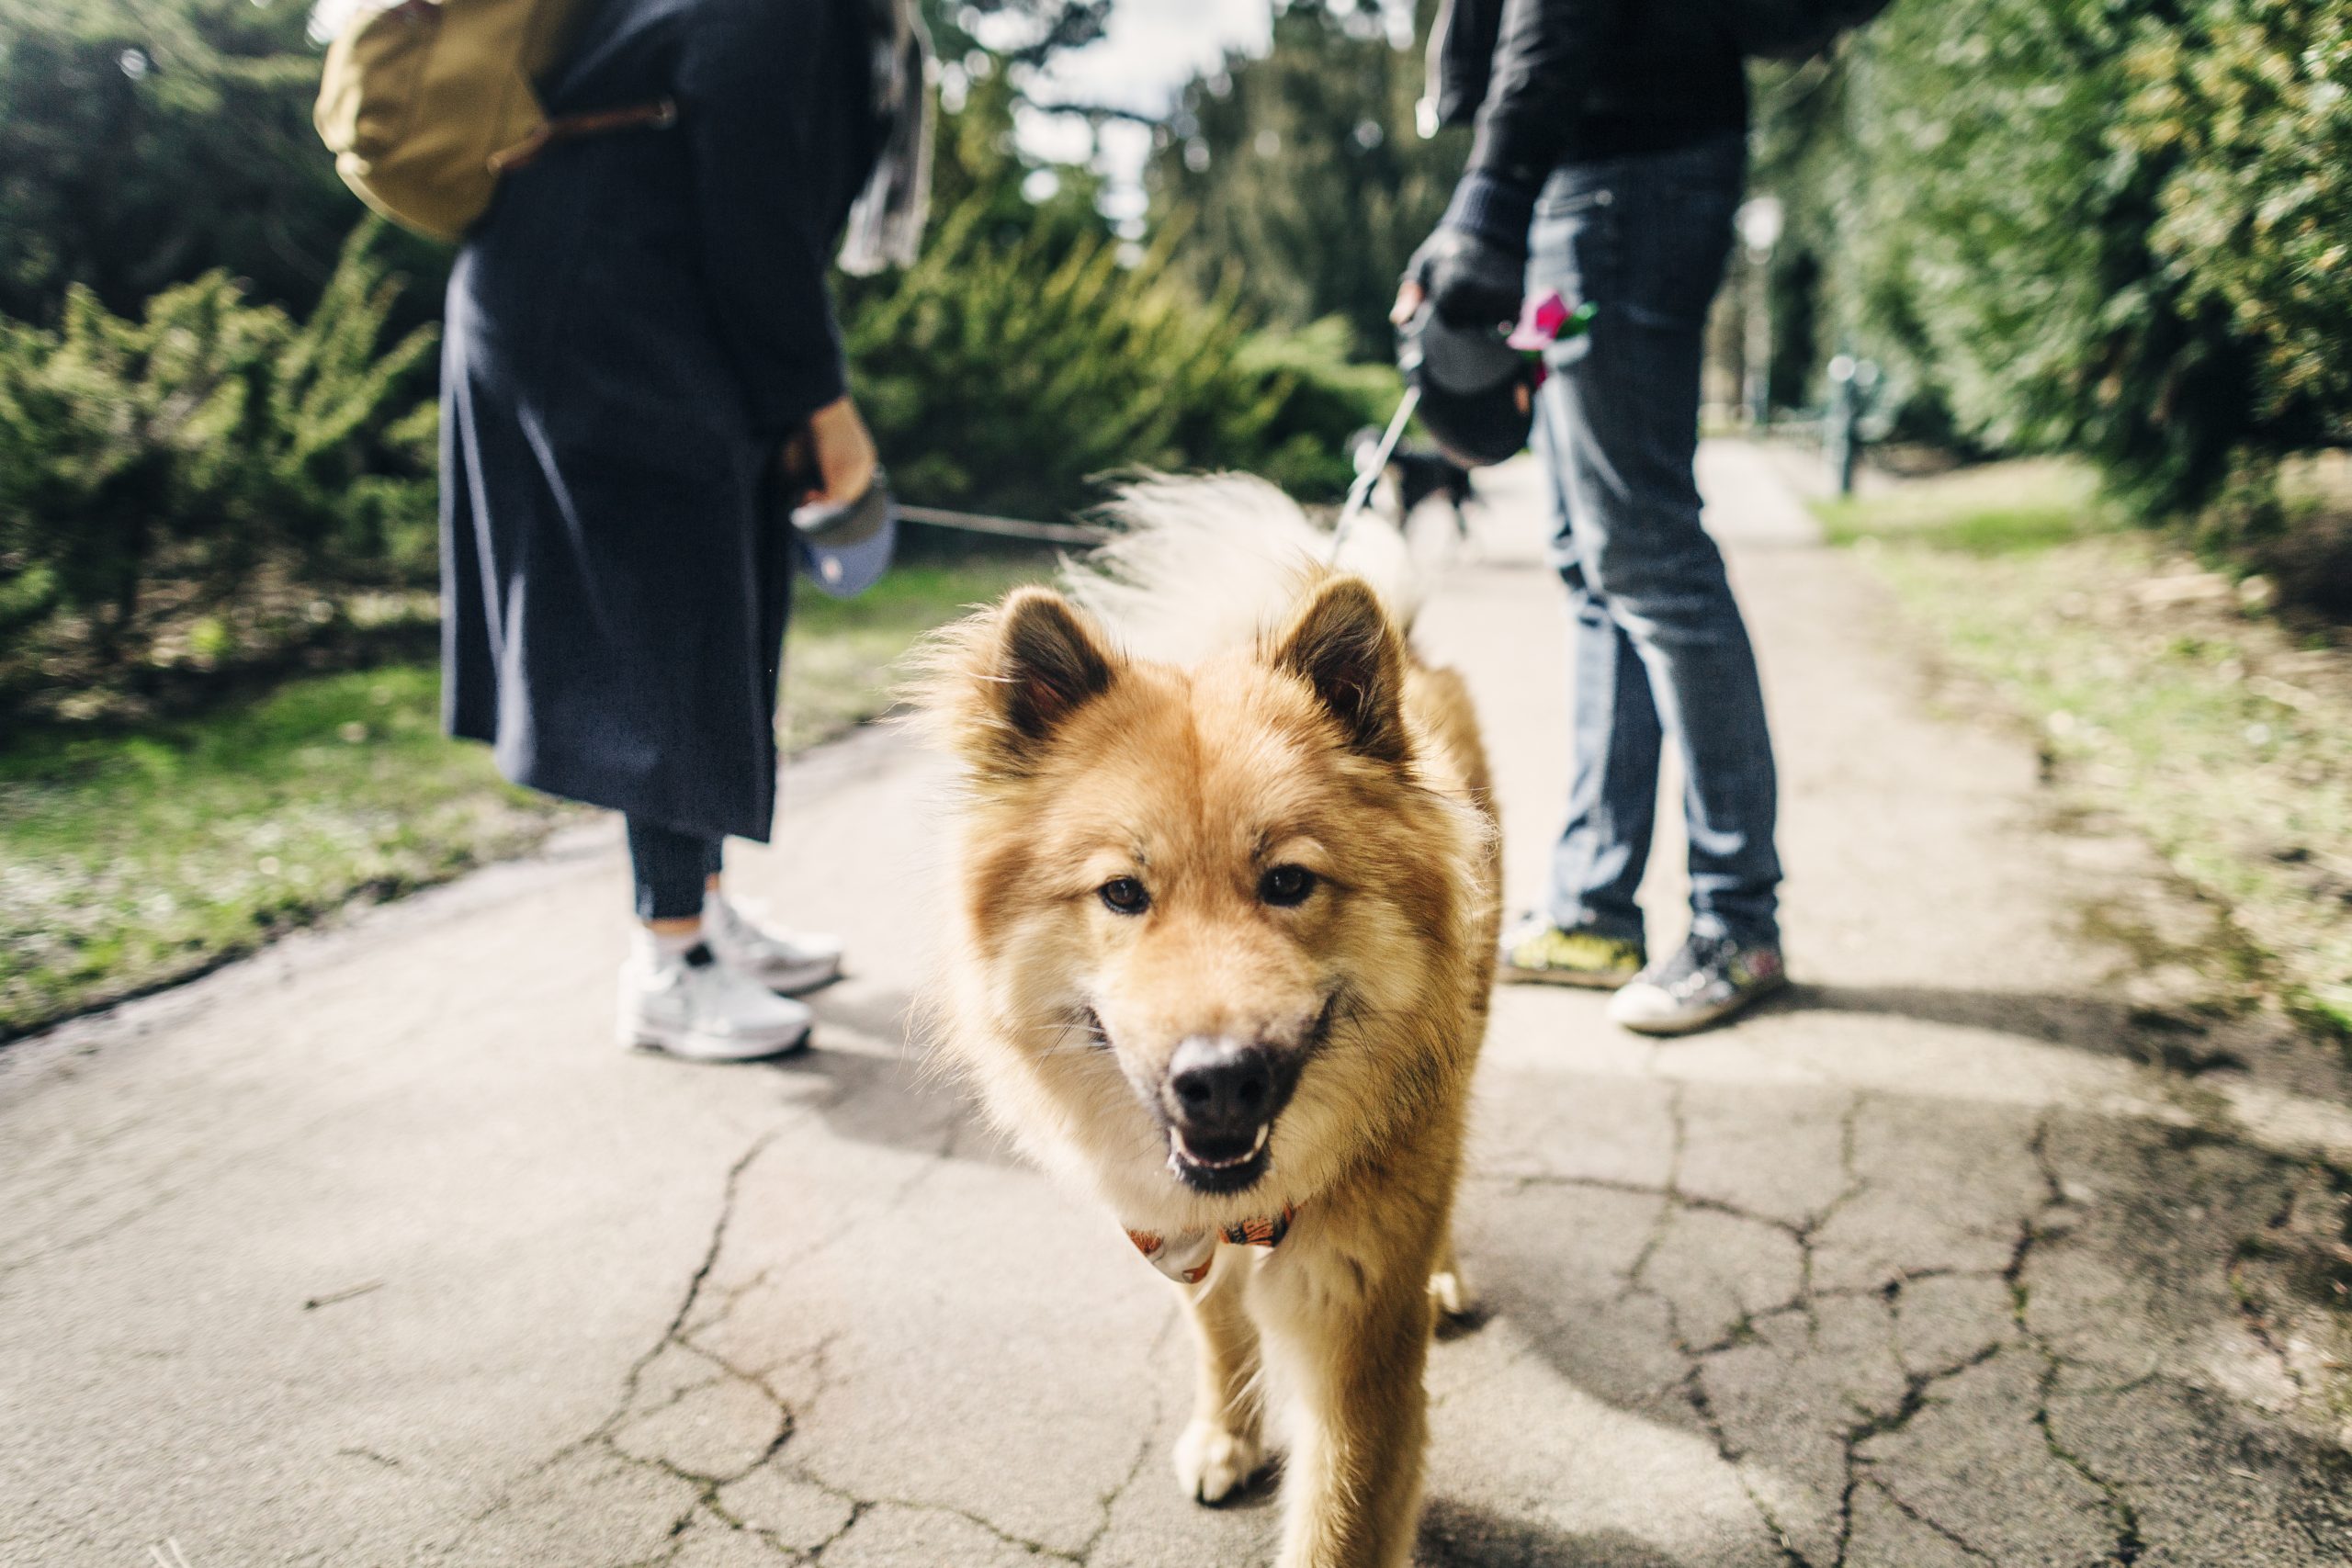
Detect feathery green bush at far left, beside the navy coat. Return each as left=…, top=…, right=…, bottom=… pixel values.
left=0, top=226, right=433, bottom=715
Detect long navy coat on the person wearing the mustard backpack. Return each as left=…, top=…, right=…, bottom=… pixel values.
left=442, top=0, right=877, bottom=840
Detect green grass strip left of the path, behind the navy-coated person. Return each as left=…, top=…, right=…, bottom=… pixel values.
left=0, top=559, right=1042, bottom=1039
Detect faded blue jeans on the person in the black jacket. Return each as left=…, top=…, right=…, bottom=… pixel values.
left=1526, top=136, right=1781, bottom=942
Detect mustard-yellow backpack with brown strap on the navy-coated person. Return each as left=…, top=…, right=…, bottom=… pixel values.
left=312, top=0, right=677, bottom=240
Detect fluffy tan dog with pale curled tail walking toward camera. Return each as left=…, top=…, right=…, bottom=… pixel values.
left=922, top=479, right=1498, bottom=1568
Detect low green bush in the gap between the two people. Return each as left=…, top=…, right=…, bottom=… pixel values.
left=840, top=50, right=1402, bottom=517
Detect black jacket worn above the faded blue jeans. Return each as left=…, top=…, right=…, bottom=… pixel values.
left=1430, top=0, right=1747, bottom=186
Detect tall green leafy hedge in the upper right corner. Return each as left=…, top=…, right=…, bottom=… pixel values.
left=1757, top=0, right=2352, bottom=547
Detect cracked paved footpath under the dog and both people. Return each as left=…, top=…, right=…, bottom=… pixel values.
left=0, top=446, right=2352, bottom=1568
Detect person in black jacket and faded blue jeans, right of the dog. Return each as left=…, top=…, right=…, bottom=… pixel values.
left=1397, top=0, right=1785, bottom=1034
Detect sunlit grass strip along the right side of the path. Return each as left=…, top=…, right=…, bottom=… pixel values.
left=1820, top=461, right=2352, bottom=1034
